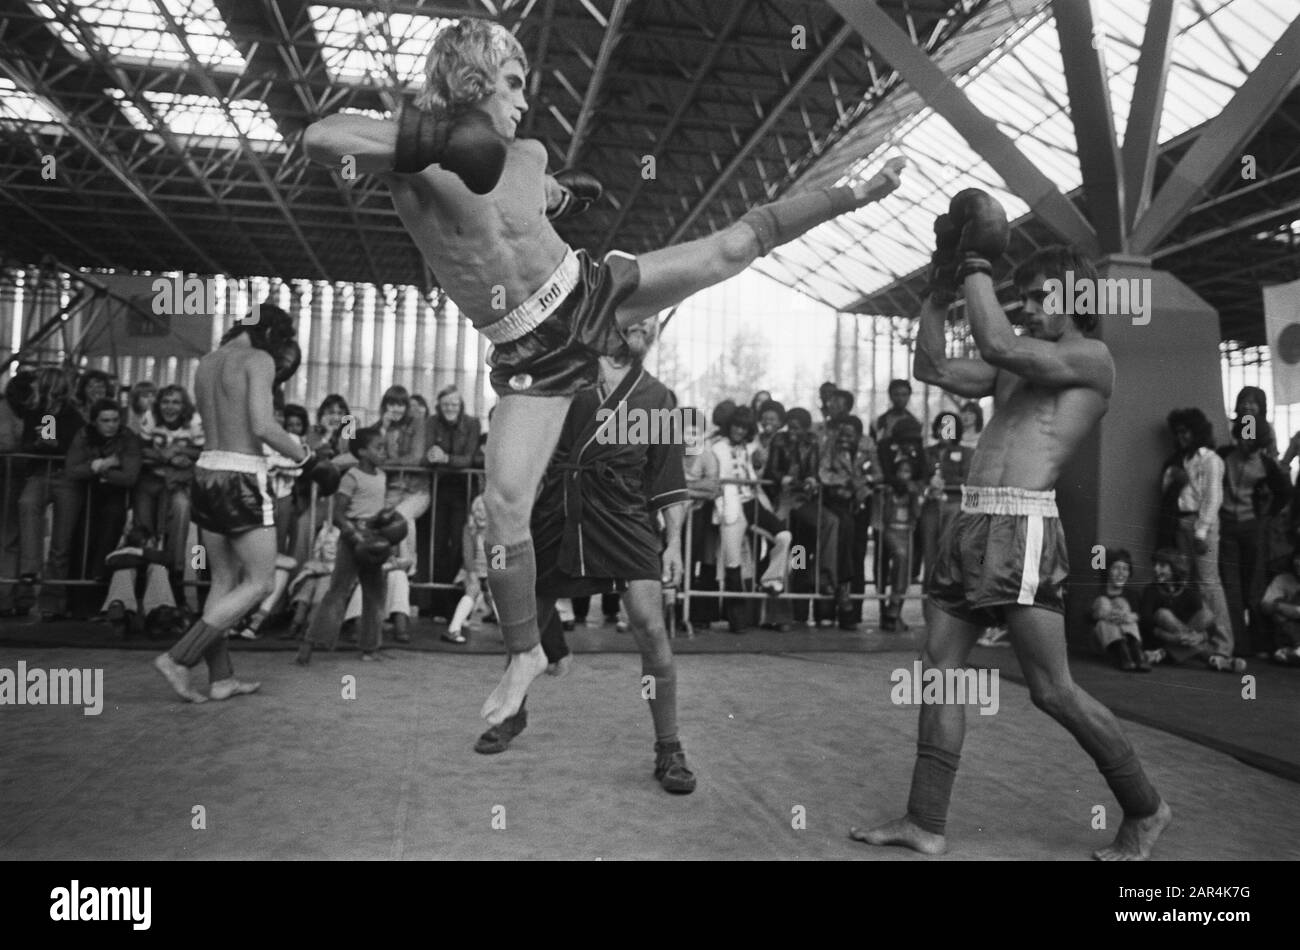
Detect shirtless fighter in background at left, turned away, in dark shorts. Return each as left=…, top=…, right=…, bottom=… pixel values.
left=153, top=305, right=312, bottom=703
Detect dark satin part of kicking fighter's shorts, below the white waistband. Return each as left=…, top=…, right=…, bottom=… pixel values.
left=488, top=251, right=641, bottom=396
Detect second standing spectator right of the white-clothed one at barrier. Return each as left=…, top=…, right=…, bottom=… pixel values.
left=818, top=415, right=872, bottom=630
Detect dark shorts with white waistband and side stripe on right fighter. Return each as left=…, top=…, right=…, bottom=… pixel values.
left=926, top=486, right=1070, bottom=626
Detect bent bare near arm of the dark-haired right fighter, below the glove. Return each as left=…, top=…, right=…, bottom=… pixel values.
left=963, top=273, right=1112, bottom=394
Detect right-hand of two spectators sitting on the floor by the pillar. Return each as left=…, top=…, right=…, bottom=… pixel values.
left=1139, top=547, right=1245, bottom=673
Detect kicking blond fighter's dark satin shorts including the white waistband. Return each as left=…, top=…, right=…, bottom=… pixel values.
left=480, top=250, right=641, bottom=396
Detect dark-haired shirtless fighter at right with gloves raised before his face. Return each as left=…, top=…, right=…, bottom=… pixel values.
left=850, top=188, right=1170, bottom=860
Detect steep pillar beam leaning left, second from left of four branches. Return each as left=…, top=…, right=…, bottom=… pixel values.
left=1052, top=0, right=1128, bottom=253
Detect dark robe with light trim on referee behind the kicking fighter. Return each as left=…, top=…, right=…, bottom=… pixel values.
left=532, top=365, right=689, bottom=598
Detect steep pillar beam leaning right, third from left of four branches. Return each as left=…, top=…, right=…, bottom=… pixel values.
left=1123, top=0, right=1180, bottom=227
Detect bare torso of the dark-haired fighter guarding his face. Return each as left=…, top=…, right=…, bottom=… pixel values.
left=966, top=370, right=1110, bottom=491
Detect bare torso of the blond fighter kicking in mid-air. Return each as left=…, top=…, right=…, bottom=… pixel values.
left=387, top=139, right=566, bottom=327
